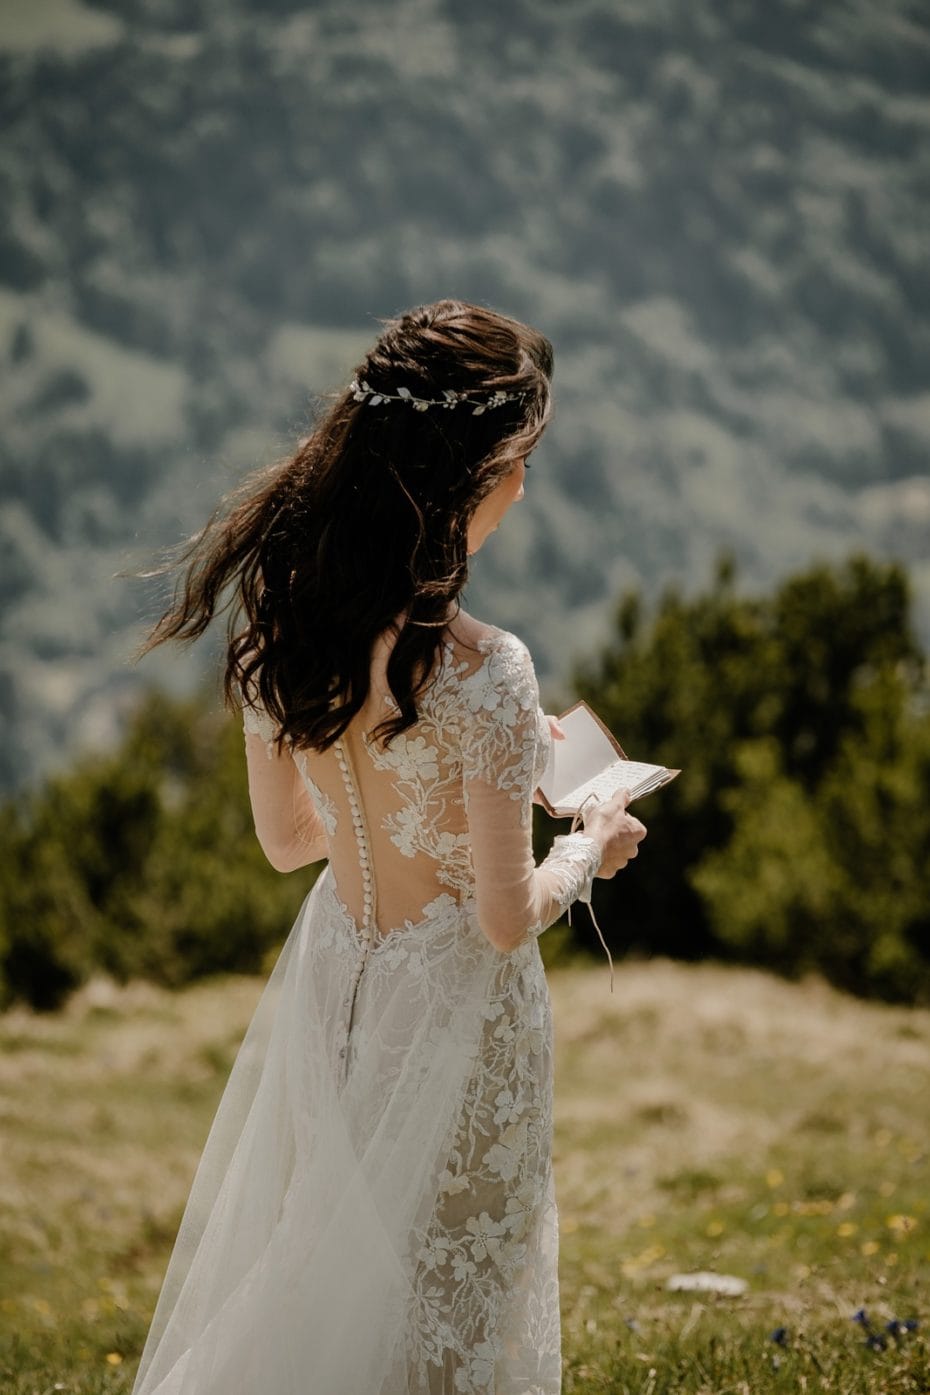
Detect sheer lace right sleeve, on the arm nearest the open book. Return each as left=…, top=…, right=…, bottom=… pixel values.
left=462, top=635, right=601, bottom=950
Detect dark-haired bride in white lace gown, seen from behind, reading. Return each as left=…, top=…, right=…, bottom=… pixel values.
left=134, top=301, right=646, bottom=1395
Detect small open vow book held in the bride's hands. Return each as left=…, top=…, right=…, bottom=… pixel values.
left=540, top=702, right=680, bottom=819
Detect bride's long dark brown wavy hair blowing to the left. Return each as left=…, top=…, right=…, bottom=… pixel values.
left=142, top=300, right=552, bottom=751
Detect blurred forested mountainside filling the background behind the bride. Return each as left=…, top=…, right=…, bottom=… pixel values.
left=0, top=0, right=930, bottom=785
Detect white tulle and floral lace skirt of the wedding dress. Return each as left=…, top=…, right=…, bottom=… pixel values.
left=134, top=870, right=561, bottom=1395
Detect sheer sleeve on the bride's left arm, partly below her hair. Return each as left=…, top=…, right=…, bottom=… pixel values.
left=243, top=706, right=329, bottom=872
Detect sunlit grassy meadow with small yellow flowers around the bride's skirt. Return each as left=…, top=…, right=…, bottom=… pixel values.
left=0, top=963, right=930, bottom=1395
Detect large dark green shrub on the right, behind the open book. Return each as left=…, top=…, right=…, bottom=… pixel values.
left=577, top=557, right=930, bottom=1000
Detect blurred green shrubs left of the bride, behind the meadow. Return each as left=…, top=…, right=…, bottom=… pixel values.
left=0, top=693, right=314, bottom=1007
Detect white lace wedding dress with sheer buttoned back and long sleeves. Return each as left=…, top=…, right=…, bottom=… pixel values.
left=134, top=621, right=600, bottom=1395
